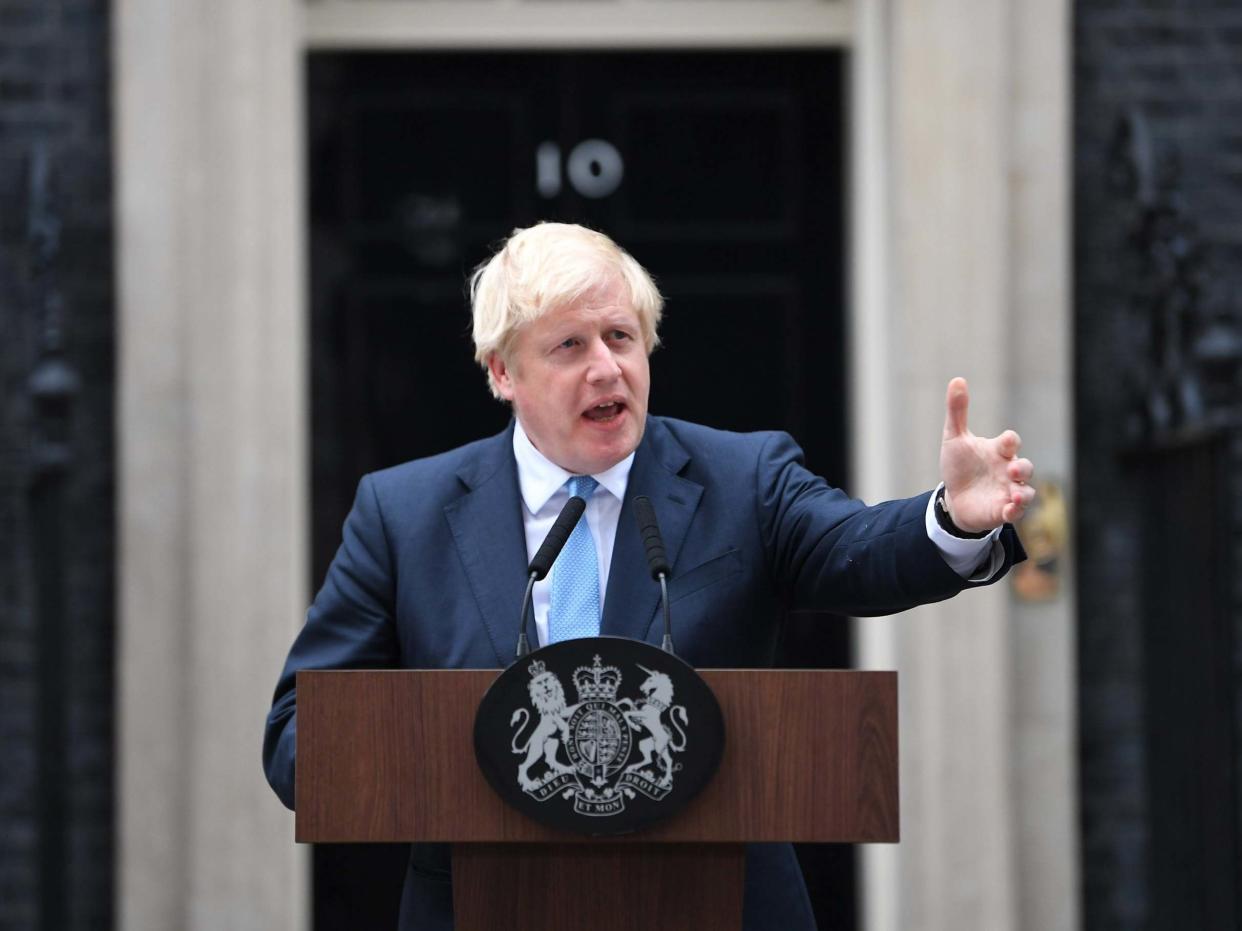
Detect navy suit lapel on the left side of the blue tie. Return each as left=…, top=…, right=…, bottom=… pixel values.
left=445, top=423, right=527, bottom=667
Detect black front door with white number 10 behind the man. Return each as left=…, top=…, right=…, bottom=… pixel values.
left=308, top=51, right=853, bottom=931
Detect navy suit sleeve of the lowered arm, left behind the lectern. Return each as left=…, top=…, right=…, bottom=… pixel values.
left=263, top=477, right=400, bottom=808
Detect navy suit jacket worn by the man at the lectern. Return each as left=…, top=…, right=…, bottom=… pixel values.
left=263, top=416, right=1023, bottom=931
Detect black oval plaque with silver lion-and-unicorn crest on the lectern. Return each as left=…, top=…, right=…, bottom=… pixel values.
left=474, top=637, right=724, bottom=835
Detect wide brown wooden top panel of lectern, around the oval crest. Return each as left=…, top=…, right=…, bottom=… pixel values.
left=297, top=669, right=899, bottom=844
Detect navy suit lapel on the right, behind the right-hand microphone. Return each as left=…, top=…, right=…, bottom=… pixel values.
left=600, top=417, right=703, bottom=641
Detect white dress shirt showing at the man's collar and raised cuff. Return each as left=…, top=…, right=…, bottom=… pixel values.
left=513, top=420, right=1005, bottom=645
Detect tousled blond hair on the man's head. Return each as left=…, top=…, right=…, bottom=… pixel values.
left=469, top=223, right=664, bottom=397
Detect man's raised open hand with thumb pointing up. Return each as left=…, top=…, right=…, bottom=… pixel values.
left=940, top=379, right=1035, bottom=533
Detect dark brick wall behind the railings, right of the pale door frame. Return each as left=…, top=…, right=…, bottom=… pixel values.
left=1074, top=0, right=1242, bottom=929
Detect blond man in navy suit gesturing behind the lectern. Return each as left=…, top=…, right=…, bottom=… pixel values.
left=263, top=223, right=1033, bottom=931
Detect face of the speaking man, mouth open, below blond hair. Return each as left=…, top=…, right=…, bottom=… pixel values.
left=488, top=279, right=651, bottom=475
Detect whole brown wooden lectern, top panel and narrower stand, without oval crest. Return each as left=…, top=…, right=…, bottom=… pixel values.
left=297, top=669, right=899, bottom=931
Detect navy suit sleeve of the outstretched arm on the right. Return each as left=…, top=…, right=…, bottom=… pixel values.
left=756, top=433, right=1025, bottom=617
